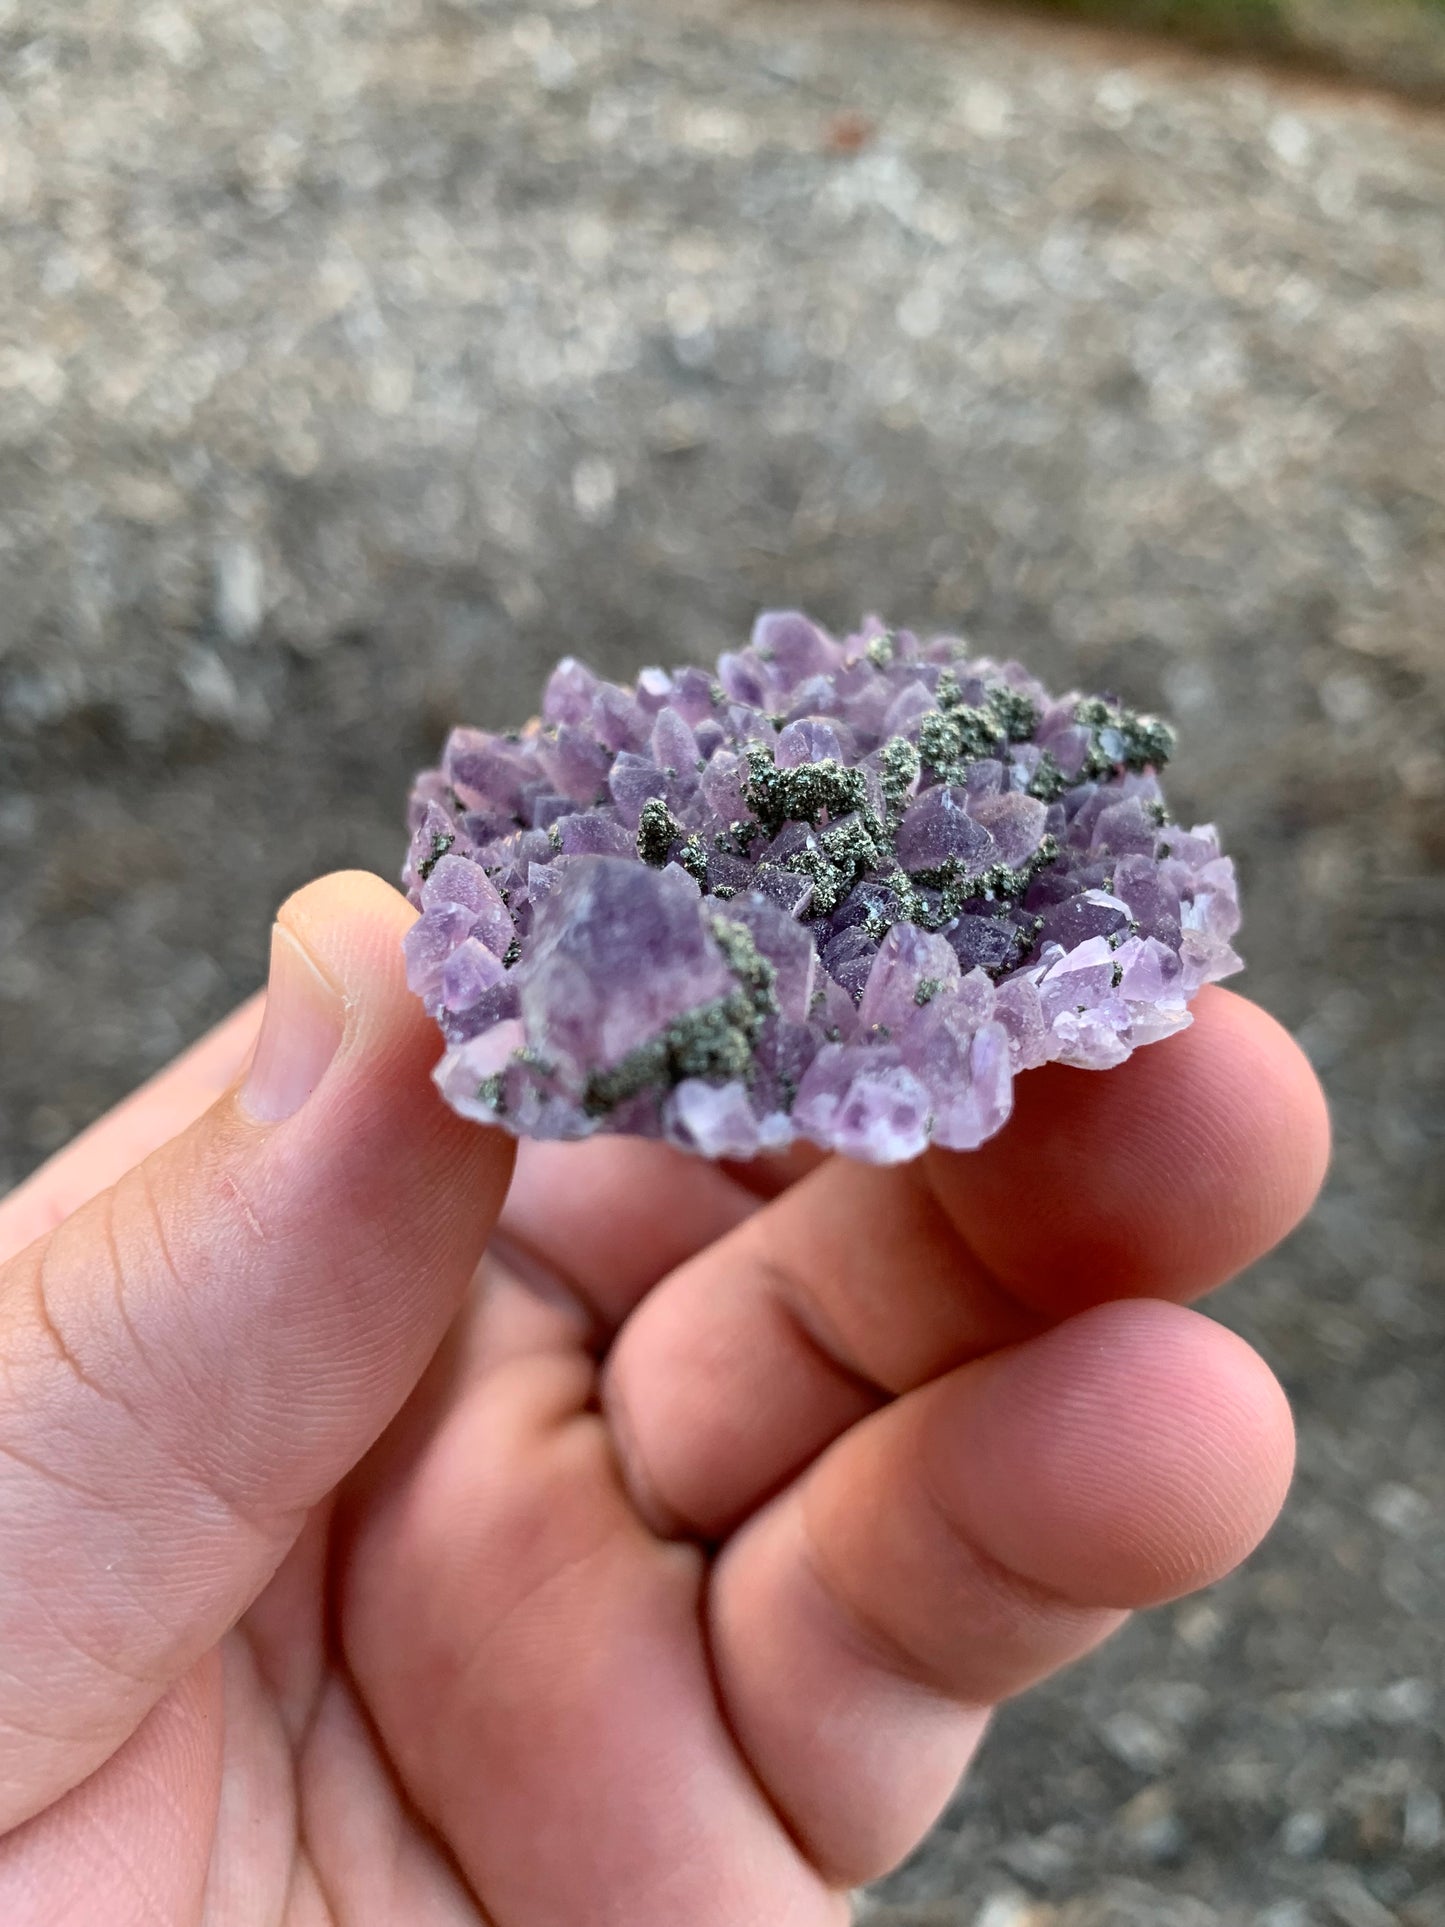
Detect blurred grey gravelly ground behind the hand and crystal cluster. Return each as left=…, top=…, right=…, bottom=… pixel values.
left=0, top=0, right=1445, bottom=1927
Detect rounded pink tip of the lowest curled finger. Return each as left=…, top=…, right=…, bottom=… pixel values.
left=940, top=1301, right=1295, bottom=1609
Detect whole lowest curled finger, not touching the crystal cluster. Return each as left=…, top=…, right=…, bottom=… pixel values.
left=711, top=1301, right=1293, bottom=1881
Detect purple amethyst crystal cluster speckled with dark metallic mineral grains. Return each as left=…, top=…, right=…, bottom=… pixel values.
left=405, top=613, right=1239, bottom=1164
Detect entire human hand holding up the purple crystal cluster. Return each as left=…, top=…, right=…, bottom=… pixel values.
left=0, top=875, right=1327, bottom=1927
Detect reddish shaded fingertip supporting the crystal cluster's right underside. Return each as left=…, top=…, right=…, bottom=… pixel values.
left=929, top=989, right=1329, bottom=1316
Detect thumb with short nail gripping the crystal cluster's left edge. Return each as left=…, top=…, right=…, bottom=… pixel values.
left=0, top=875, right=511, bottom=1831
